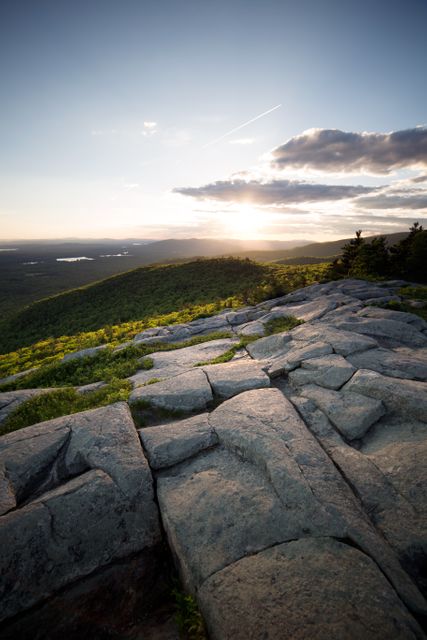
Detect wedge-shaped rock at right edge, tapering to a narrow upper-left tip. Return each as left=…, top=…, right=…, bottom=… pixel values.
left=292, top=396, right=427, bottom=592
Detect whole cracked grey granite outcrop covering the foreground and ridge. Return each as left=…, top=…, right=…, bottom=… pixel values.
left=0, top=280, right=427, bottom=640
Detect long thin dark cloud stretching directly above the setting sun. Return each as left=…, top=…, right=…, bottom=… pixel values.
left=174, top=180, right=376, bottom=205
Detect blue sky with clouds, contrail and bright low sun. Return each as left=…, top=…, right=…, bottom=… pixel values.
left=0, top=0, right=427, bottom=241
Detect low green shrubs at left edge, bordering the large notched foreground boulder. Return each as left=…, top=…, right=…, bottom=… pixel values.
left=0, top=380, right=131, bottom=435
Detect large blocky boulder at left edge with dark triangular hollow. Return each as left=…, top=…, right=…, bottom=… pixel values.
left=0, top=403, right=160, bottom=619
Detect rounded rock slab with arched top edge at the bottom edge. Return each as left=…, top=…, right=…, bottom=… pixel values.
left=199, top=538, right=422, bottom=640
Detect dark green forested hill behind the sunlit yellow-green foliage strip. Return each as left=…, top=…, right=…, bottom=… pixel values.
left=0, top=258, right=332, bottom=353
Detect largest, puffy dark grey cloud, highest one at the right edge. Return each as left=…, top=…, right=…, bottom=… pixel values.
left=272, top=127, right=427, bottom=174
